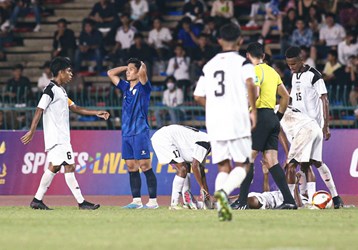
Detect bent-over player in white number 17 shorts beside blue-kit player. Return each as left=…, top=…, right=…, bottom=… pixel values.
left=151, top=125, right=211, bottom=210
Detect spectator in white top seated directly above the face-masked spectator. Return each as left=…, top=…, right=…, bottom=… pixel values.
left=166, top=44, right=191, bottom=93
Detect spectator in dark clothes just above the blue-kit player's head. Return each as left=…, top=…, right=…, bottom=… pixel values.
left=128, top=33, right=156, bottom=79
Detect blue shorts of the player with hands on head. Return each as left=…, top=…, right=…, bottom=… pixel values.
left=122, top=130, right=150, bottom=160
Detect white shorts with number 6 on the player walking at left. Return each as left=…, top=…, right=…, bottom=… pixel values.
left=47, top=144, right=75, bottom=166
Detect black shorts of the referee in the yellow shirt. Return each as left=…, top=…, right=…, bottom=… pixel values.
left=252, top=108, right=280, bottom=152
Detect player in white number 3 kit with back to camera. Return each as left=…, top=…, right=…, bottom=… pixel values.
left=194, top=24, right=257, bottom=220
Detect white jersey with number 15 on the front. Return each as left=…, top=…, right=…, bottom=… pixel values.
left=290, top=66, right=327, bottom=128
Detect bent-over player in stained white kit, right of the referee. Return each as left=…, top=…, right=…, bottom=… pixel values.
left=279, top=106, right=343, bottom=209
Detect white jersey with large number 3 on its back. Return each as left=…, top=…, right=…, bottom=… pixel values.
left=194, top=51, right=256, bottom=141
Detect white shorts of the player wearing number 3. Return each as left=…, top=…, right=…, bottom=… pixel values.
left=210, top=136, right=252, bottom=164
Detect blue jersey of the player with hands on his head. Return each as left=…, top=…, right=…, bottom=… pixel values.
left=117, top=79, right=152, bottom=136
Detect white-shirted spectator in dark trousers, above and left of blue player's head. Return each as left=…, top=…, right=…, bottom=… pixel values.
left=108, top=13, right=137, bottom=65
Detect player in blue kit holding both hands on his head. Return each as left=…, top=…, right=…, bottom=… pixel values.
left=107, top=58, right=158, bottom=209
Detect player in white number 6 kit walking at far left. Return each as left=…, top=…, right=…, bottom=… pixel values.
left=21, top=57, right=109, bottom=210
